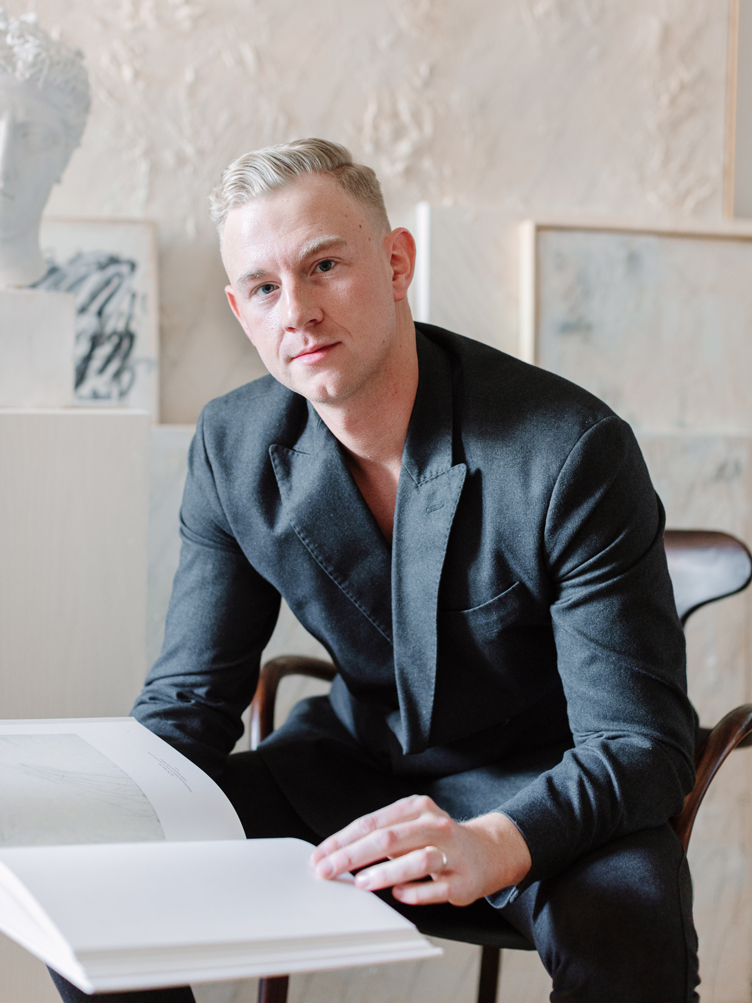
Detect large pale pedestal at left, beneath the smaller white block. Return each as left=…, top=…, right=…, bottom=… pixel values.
left=0, top=409, right=149, bottom=717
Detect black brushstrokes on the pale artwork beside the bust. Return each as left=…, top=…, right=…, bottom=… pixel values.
left=32, top=251, right=138, bottom=401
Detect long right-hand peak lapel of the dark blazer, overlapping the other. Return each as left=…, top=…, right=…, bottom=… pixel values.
left=389, top=333, right=467, bottom=753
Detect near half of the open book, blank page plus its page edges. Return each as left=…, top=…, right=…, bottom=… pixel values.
left=0, top=839, right=441, bottom=992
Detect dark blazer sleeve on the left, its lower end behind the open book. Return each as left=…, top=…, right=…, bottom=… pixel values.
left=131, top=407, right=280, bottom=777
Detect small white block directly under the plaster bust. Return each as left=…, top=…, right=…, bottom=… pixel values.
left=0, top=289, right=75, bottom=407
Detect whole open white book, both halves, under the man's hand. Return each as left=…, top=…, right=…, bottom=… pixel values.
left=0, top=717, right=441, bottom=993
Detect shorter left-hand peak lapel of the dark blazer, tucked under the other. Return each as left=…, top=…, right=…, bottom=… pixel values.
left=269, top=405, right=392, bottom=643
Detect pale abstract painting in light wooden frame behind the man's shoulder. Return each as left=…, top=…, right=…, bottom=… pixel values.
left=520, top=222, right=752, bottom=434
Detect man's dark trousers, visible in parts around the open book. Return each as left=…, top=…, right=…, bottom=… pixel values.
left=51, top=752, right=699, bottom=1003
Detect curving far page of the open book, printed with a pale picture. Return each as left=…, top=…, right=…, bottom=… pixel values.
left=0, top=717, right=245, bottom=847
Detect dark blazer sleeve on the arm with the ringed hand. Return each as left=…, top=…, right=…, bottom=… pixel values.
left=491, top=416, right=697, bottom=906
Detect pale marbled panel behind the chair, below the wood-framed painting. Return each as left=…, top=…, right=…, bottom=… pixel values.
left=640, top=435, right=752, bottom=1003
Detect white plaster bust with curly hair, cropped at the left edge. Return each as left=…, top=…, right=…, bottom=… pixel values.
left=0, top=8, right=90, bottom=289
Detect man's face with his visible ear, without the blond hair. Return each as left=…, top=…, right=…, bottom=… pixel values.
left=223, top=175, right=414, bottom=404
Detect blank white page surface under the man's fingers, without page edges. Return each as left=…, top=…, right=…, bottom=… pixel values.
left=0, top=840, right=425, bottom=953
